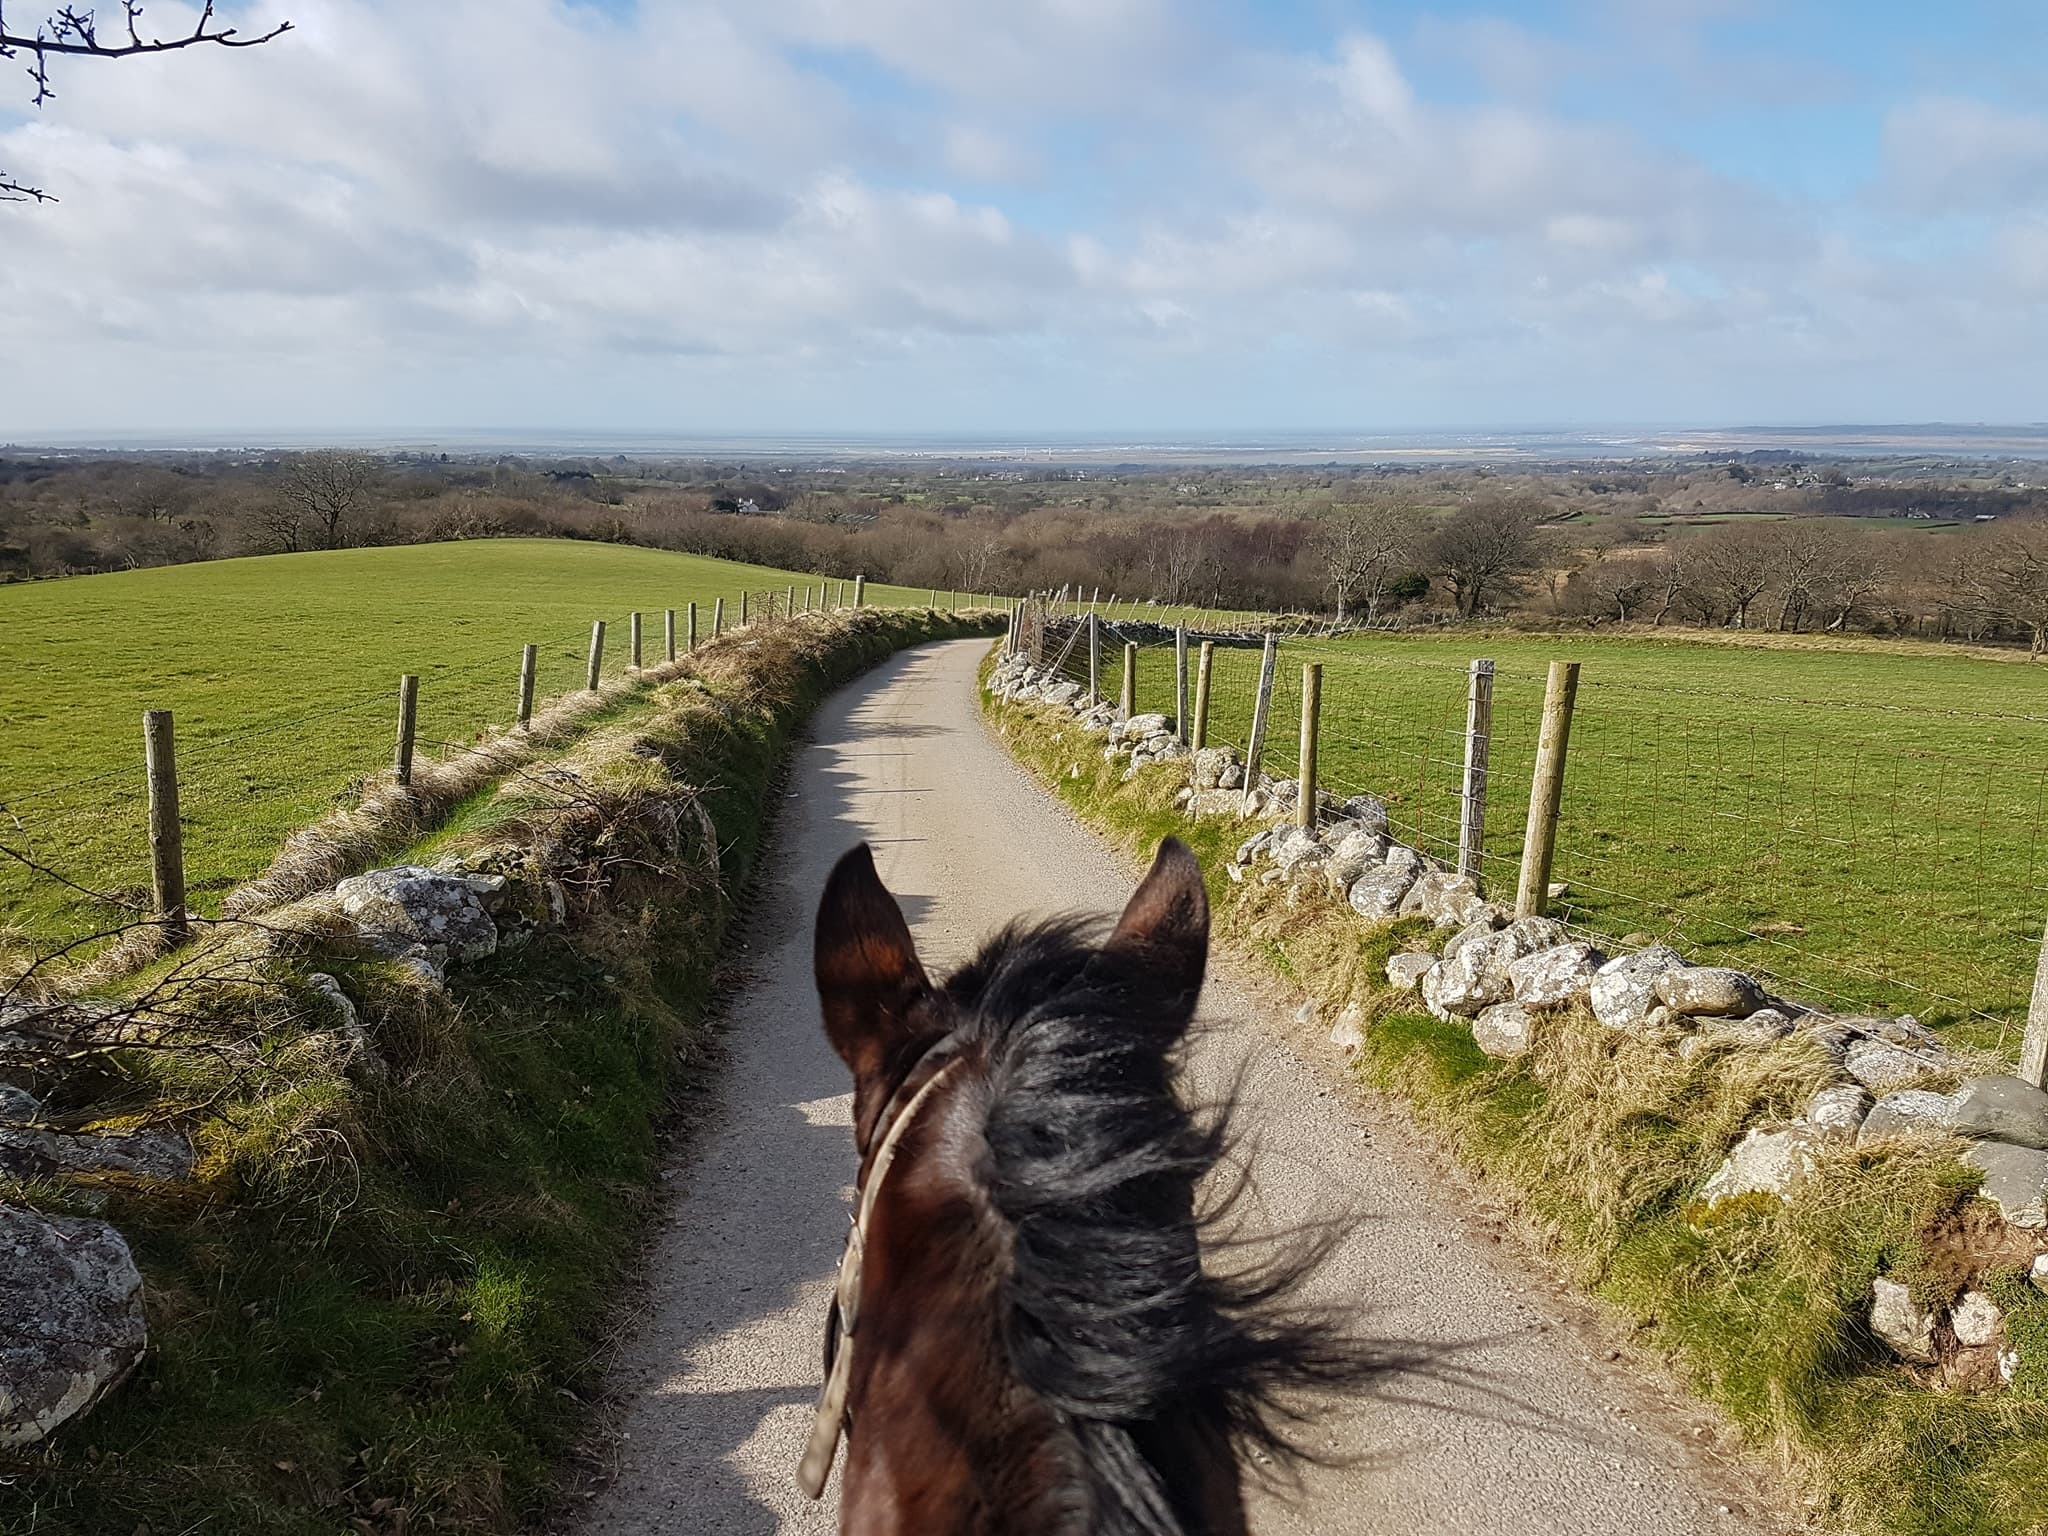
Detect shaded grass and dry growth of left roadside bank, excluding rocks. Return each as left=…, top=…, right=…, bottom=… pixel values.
left=0, top=610, right=991, bottom=1536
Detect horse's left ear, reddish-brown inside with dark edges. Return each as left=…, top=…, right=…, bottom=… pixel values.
left=811, top=844, right=932, bottom=1087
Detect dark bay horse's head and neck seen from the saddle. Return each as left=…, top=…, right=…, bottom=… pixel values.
left=801, top=840, right=1368, bottom=1536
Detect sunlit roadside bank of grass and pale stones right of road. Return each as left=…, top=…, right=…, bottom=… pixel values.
left=985, top=659, right=2048, bottom=1536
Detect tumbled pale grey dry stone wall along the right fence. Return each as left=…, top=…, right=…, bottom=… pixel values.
left=987, top=655, right=2048, bottom=1389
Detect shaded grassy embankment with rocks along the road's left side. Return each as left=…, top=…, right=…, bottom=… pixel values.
left=0, top=610, right=993, bottom=1534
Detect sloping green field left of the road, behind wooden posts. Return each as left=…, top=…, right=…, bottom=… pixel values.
left=0, top=539, right=944, bottom=938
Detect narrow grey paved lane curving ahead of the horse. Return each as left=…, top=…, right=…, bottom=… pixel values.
left=582, top=641, right=1763, bottom=1536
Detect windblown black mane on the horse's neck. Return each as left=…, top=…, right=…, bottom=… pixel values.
left=944, top=920, right=1376, bottom=1536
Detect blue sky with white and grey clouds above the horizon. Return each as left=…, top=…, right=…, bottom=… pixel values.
left=0, top=0, right=2048, bottom=440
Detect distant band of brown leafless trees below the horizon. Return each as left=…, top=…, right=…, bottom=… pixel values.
left=12, top=453, right=2048, bottom=653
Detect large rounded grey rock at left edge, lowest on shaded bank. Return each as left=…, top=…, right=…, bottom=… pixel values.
left=0, top=1206, right=150, bottom=1448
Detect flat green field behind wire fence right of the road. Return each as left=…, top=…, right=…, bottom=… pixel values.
left=1097, top=633, right=2048, bottom=1047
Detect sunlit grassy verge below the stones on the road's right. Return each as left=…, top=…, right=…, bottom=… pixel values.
left=989, top=684, right=2048, bottom=1536
